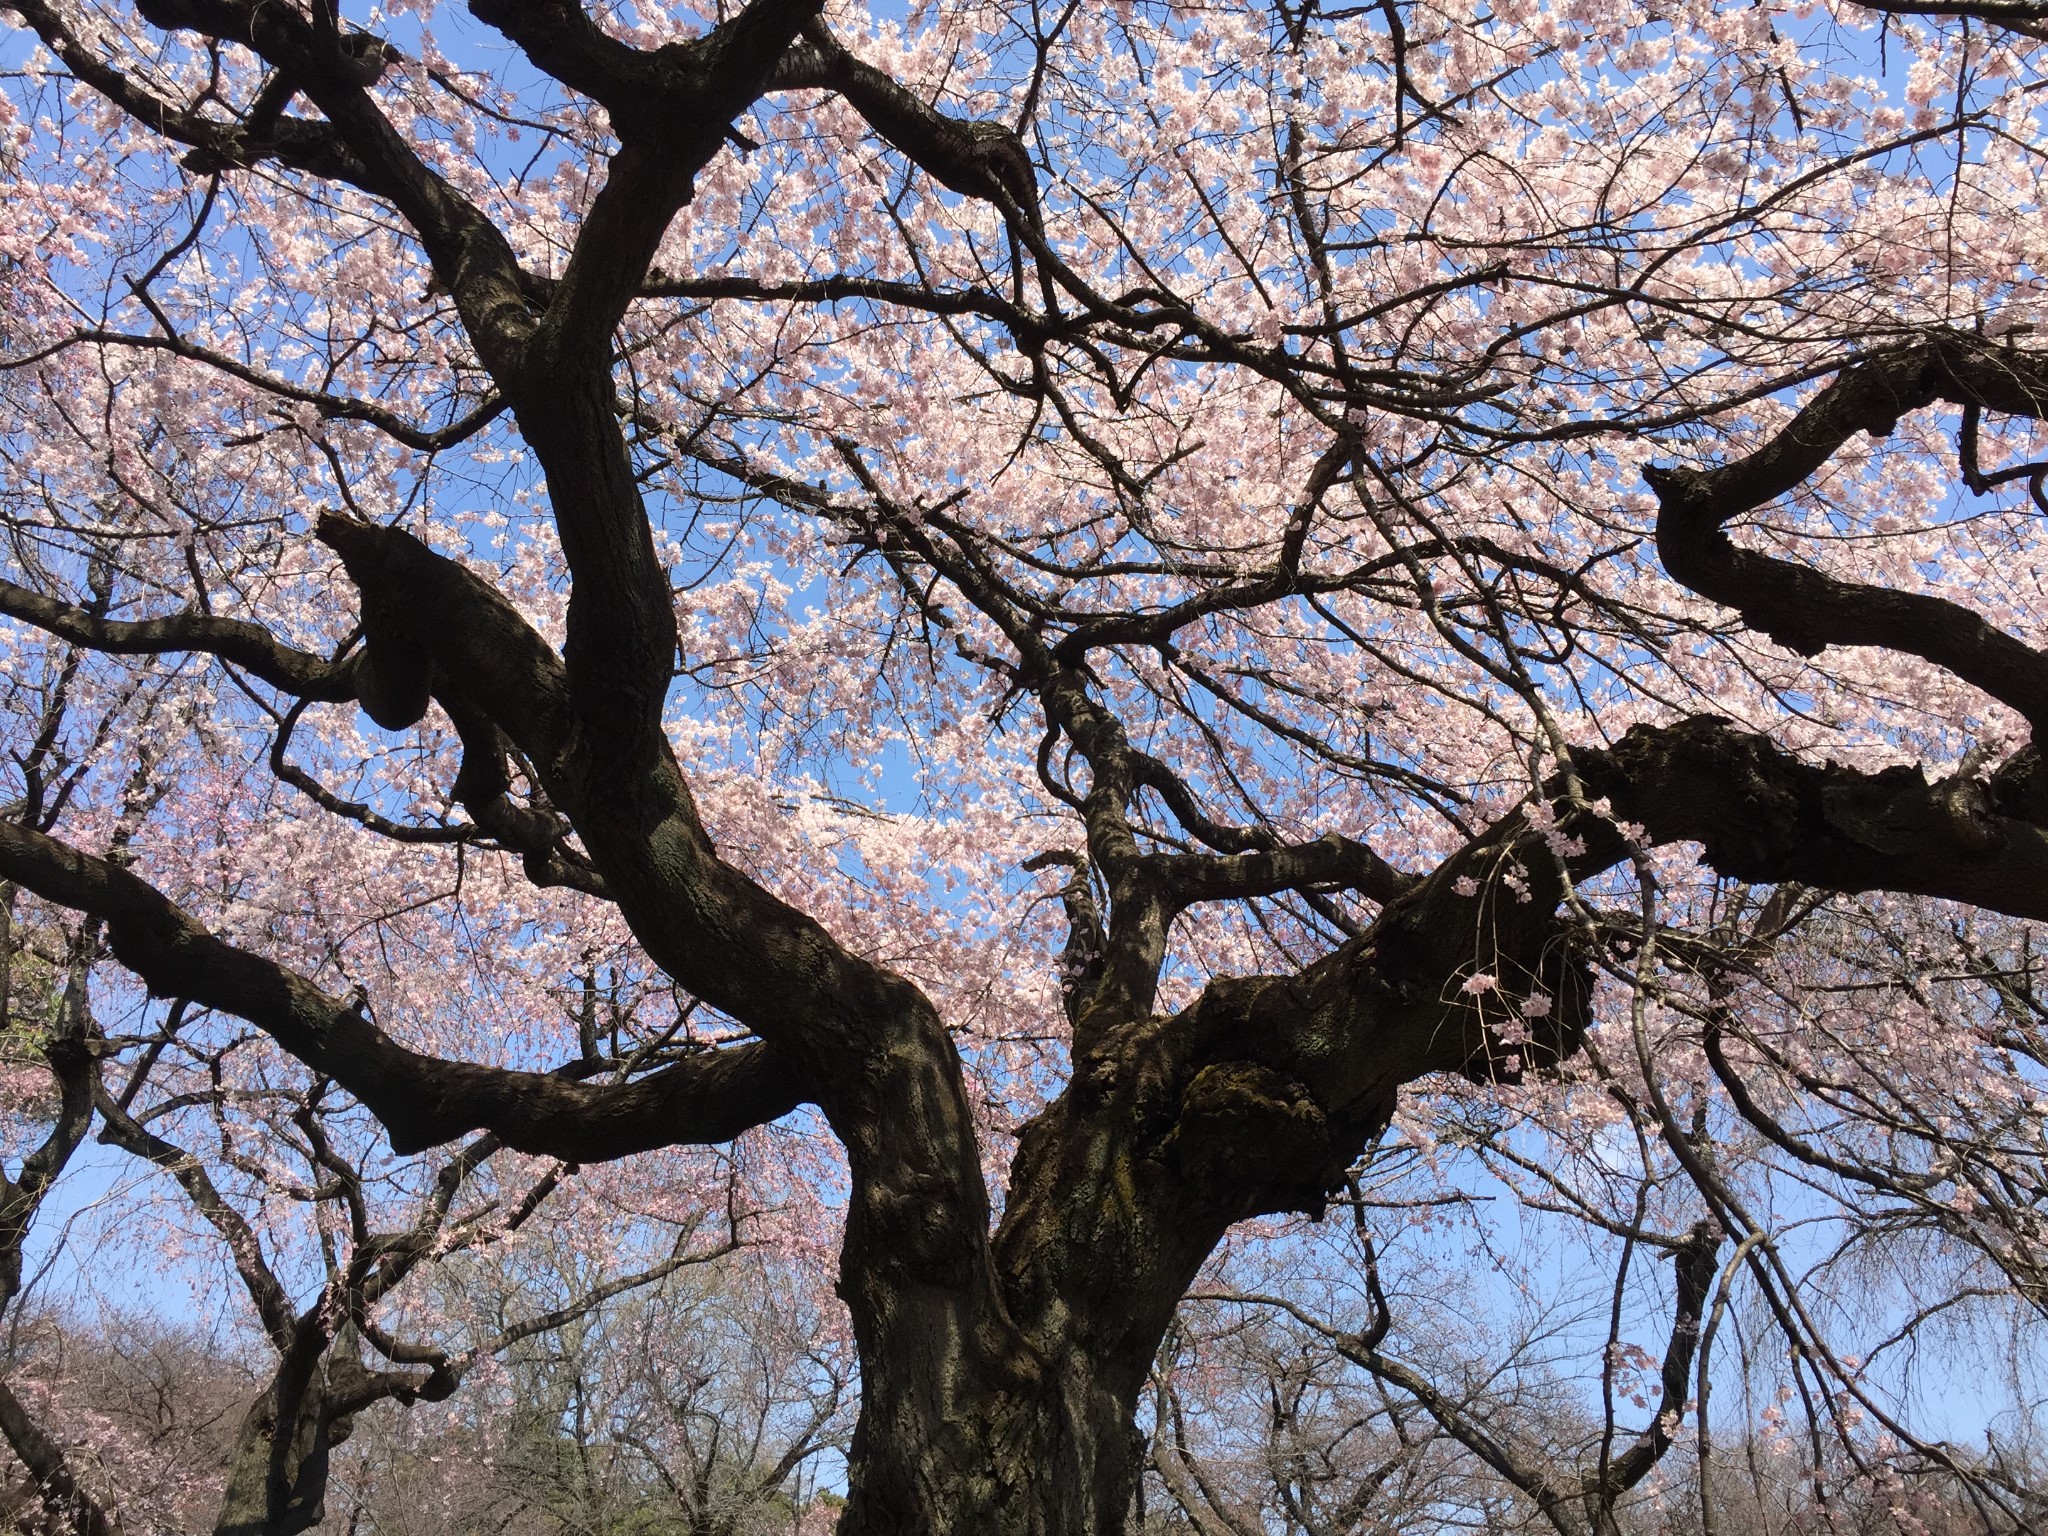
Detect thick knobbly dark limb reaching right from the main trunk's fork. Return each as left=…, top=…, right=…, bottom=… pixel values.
left=997, top=688, right=2048, bottom=1343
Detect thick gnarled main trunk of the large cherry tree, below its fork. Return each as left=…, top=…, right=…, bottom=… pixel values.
left=823, top=1092, right=1362, bottom=1536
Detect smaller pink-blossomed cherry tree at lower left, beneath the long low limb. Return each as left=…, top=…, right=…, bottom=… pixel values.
left=0, top=770, right=802, bottom=1532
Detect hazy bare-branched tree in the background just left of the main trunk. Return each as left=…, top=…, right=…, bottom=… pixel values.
left=325, top=1253, right=850, bottom=1536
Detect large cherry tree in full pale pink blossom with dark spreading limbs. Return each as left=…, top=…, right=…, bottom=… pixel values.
left=0, top=0, right=2048, bottom=1534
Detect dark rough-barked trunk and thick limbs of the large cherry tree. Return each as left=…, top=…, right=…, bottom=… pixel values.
left=0, top=0, right=2048, bottom=1536
